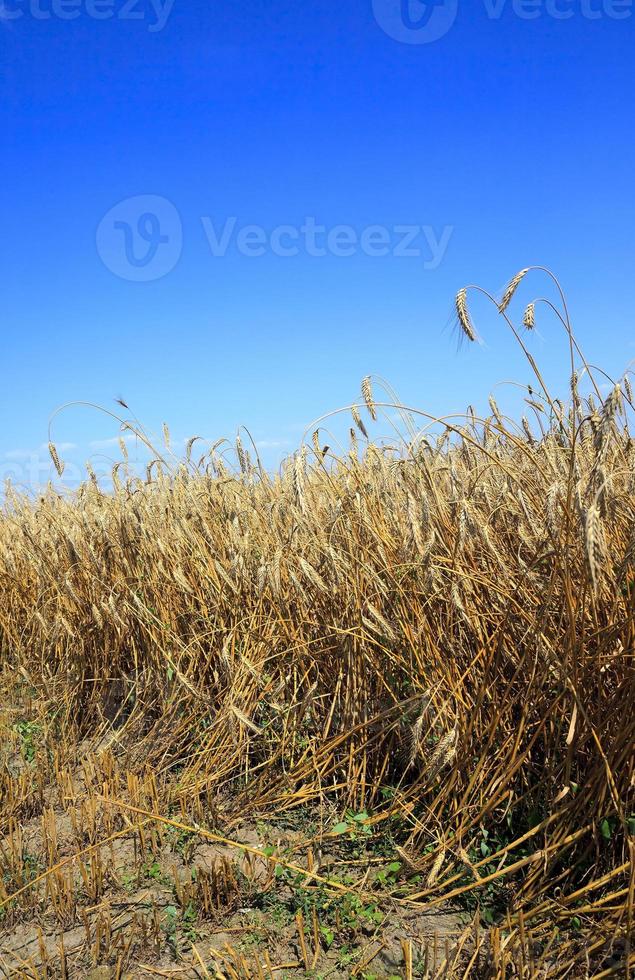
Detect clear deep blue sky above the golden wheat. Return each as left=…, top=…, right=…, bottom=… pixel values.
left=0, top=0, right=635, bottom=482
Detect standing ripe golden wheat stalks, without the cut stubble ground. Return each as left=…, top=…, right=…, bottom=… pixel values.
left=0, top=270, right=635, bottom=976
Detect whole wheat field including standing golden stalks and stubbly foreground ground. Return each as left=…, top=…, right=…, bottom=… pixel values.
left=0, top=269, right=635, bottom=980
